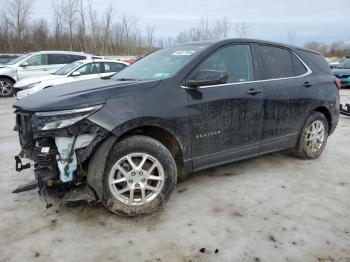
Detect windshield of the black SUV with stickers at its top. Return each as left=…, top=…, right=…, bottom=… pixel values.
left=112, top=44, right=208, bottom=80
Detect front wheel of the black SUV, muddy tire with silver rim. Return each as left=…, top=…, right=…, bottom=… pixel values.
left=102, top=135, right=177, bottom=216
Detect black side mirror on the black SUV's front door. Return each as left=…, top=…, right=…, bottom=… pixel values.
left=186, top=70, right=228, bottom=87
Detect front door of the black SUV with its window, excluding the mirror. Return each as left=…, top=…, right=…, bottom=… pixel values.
left=186, top=44, right=264, bottom=170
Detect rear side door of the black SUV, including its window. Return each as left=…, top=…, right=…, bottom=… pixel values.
left=255, top=44, right=317, bottom=152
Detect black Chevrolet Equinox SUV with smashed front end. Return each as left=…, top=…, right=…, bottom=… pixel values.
left=14, top=39, right=339, bottom=216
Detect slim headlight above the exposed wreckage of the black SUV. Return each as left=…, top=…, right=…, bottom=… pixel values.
left=35, top=105, right=103, bottom=131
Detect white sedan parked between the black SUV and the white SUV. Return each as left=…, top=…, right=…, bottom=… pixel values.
left=14, top=59, right=128, bottom=99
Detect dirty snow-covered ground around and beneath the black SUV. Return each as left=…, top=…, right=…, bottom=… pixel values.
left=0, top=90, right=350, bottom=262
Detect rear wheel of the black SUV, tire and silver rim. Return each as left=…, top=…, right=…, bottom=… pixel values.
left=292, top=112, right=329, bottom=159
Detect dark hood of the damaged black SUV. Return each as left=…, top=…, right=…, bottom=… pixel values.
left=13, top=79, right=160, bottom=112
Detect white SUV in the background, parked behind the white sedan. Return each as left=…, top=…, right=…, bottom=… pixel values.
left=0, top=51, right=100, bottom=97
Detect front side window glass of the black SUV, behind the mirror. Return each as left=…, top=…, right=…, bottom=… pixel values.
left=190, top=45, right=254, bottom=83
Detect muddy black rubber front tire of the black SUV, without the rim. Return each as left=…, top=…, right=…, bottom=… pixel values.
left=102, top=135, right=177, bottom=216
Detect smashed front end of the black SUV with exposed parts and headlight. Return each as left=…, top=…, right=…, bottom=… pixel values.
left=13, top=105, right=108, bottom=205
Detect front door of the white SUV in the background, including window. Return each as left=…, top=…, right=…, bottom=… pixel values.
left=17, top=54, right=50, bottom=81
